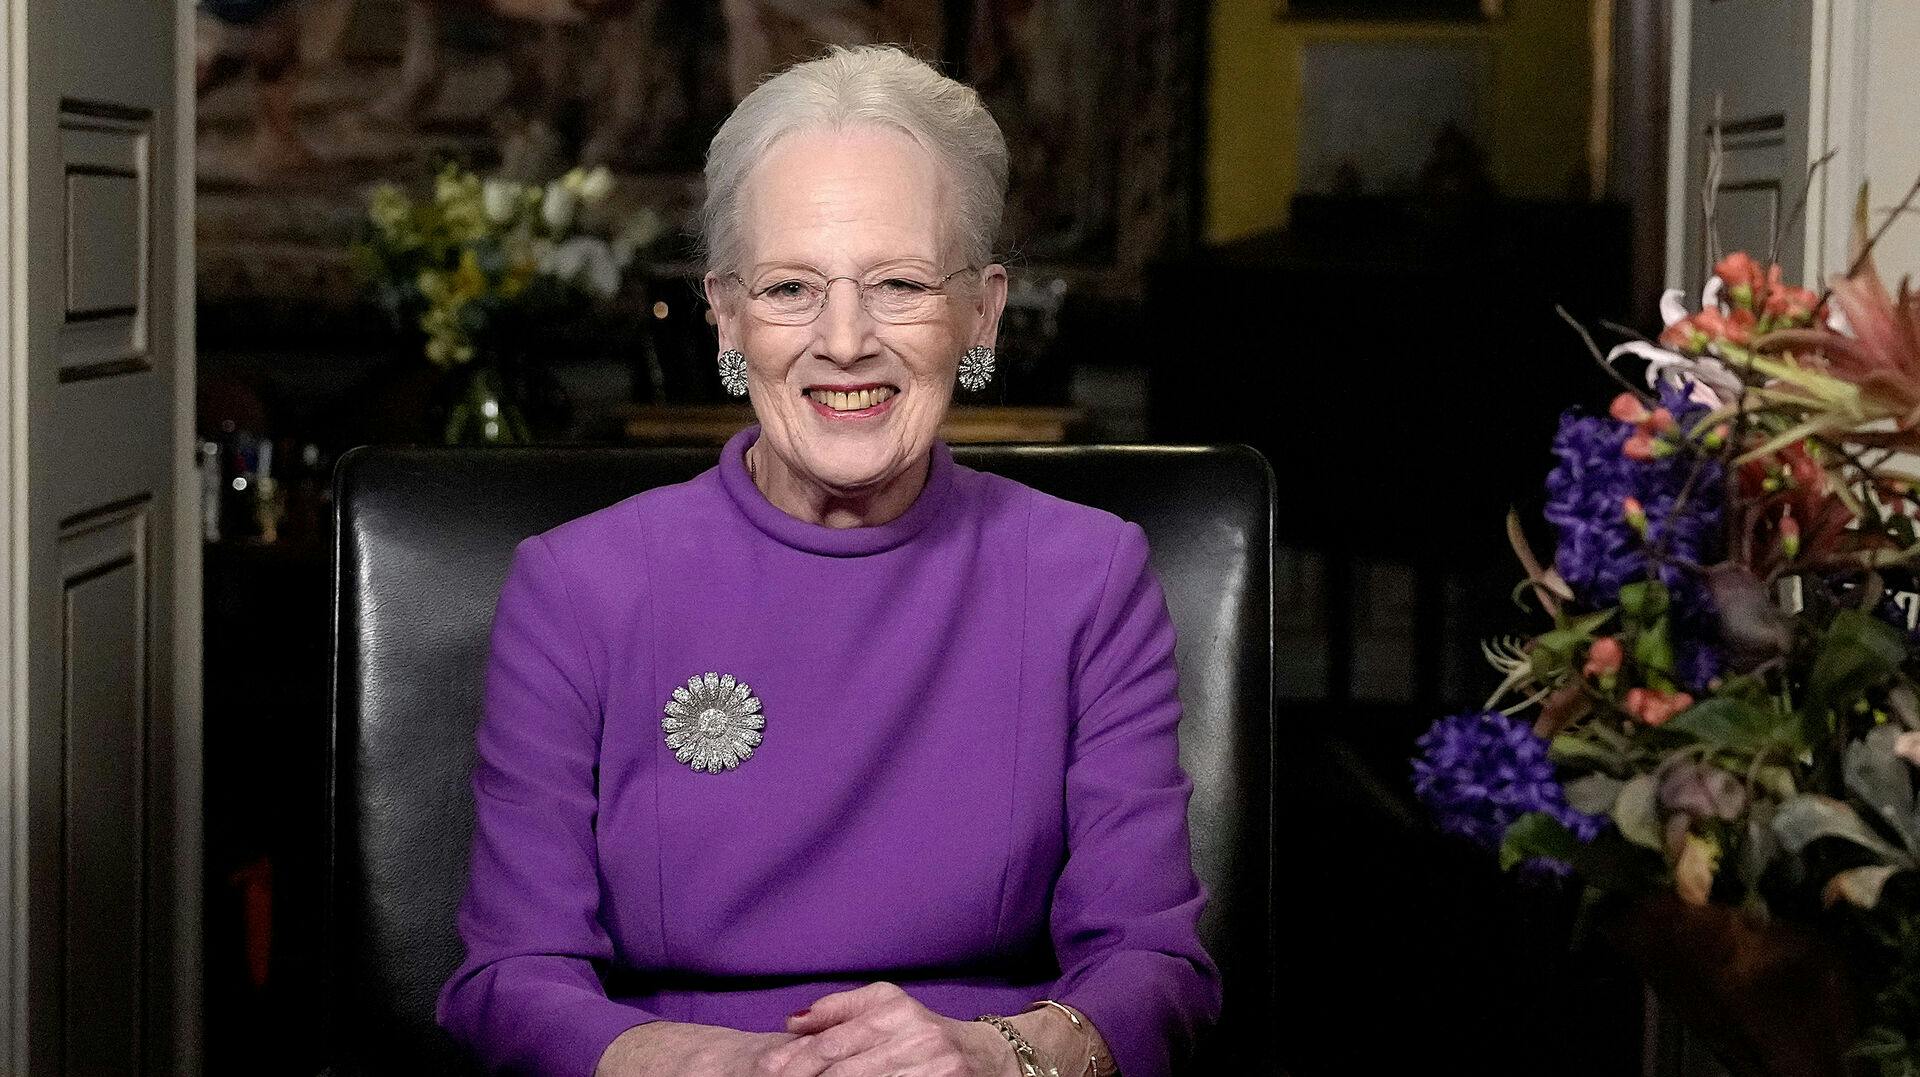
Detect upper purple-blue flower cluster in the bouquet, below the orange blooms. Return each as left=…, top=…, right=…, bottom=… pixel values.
left=1546, top=384, right=1726, bottom=691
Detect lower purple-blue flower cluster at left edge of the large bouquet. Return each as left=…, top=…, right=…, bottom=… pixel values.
left=1413, top=710, right=1607, bottom=875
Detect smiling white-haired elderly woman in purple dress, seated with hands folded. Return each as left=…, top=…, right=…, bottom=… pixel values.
left=440, top=48, right=1219, bottom=1077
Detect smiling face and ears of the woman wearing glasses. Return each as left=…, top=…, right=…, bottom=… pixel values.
left=707, top=127, right=1006, bottom=499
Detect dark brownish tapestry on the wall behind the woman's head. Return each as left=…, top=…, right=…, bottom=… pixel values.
left=196, top=0, right=1198, bottom=303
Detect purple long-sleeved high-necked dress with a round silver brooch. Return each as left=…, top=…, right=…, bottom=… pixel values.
left=440, top=428, right=1221, bottom=1077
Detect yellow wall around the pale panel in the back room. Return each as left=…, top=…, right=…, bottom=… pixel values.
left=1206, top=0, right=1592, bottom=242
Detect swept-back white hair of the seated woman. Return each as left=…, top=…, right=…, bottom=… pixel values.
left=699, top=44, right=1006, bottom=271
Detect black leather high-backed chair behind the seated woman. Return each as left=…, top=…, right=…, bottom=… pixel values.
left=324, top=445, right=1275, bottom=1075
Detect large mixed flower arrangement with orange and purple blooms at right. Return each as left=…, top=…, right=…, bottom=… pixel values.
left=1413, top=184, right=1920, bottom=1077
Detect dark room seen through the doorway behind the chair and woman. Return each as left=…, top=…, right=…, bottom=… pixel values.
left=198, top=0, right=1667, bottom=1077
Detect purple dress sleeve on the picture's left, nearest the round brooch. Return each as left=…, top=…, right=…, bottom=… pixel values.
left=438, top=536, right=655, bottom=1077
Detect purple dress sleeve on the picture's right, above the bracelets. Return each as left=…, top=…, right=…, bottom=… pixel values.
left=1052, top=524, right=1221, bottom=1077
